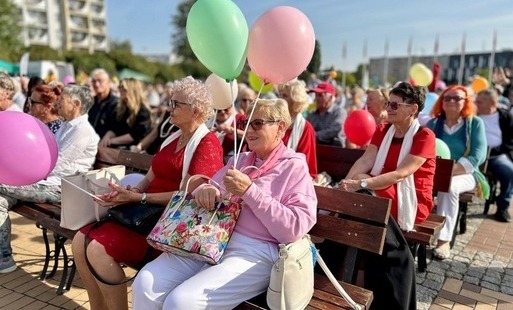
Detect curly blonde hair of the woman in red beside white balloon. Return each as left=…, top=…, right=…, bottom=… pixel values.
left=173, top=76, right=214, bottom=123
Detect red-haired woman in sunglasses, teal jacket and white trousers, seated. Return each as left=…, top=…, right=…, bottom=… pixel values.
left=427, top=85, right=489, bottom=259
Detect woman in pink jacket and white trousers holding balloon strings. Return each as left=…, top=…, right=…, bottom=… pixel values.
left=132, top=99, right=317, bottom=309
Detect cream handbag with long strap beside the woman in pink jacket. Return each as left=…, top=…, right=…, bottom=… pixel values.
left=267, top=235, right=361, bottom=310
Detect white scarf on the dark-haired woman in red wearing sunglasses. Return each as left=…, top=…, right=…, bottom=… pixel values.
left=371, top=119, right=420, bottom=231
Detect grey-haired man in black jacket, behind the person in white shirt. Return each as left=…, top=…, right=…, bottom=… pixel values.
left=89, top=69, right=119, bottom=139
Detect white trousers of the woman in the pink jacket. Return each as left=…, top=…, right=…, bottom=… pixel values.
left=132, top=232, right=278, bottom=310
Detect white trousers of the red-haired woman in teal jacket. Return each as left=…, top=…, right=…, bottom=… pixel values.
left=436, top=173, right=476, bottom=241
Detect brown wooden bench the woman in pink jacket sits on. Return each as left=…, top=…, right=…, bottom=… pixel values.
left=236, top=187, right=391, bottom=310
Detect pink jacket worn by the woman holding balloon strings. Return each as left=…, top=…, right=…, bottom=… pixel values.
left=209, top=145, right=317, bottom=243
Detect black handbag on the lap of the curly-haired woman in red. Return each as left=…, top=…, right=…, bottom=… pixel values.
left=103, top=202, right=165, bottom=235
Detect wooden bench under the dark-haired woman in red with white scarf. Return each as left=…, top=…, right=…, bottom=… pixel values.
left=316, top=145, right=448, bottom=272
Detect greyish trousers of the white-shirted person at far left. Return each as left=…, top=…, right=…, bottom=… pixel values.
left=0, top=184, right=61, bottom=257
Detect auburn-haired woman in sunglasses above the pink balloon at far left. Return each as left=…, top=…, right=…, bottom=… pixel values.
left=27, top=85, right=62, bottom=134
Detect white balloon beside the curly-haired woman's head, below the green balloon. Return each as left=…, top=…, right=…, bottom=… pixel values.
left=205, top=73, right=238, bottom=110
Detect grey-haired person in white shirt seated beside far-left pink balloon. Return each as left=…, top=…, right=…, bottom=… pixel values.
left=0, top=85, right=100, bottom=273
